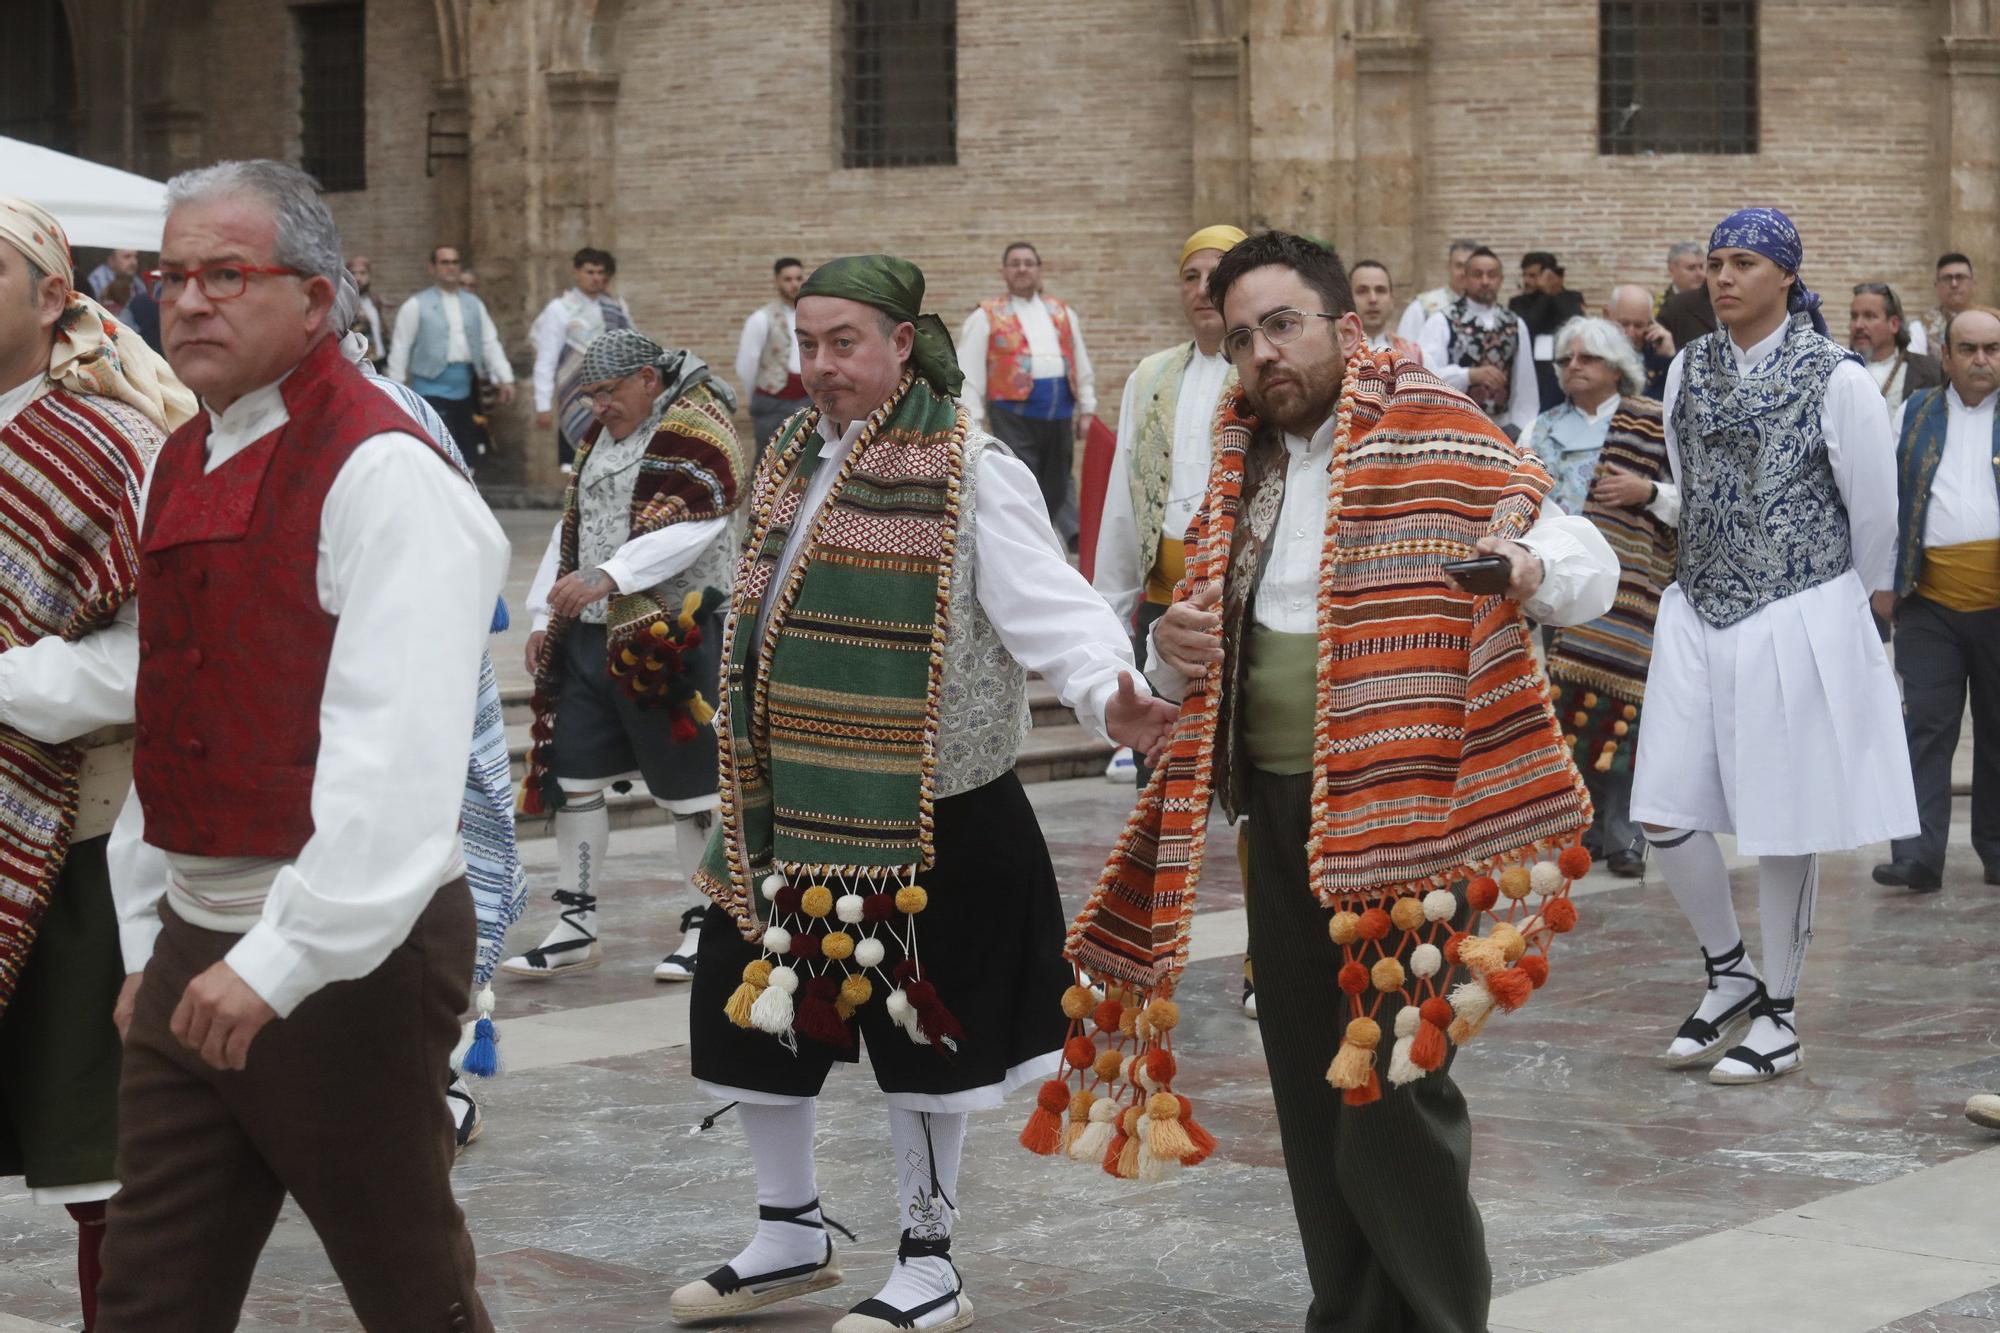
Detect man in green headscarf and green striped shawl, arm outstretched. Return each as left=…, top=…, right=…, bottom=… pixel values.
left=672, top=254, right=1174, bottom=1333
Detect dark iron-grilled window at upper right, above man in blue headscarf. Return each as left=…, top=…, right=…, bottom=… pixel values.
left=1598, top=0, right=1758, bottom=156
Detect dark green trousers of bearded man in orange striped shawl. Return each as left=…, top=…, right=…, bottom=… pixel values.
left=1246, top=771, right=1492, bottom=1333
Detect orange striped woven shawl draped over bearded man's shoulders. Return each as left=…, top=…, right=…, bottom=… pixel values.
left=1066, top=352, right=1590, bottom=989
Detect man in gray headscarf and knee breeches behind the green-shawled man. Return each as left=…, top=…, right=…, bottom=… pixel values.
left=502, top=328, right=742, bottom=981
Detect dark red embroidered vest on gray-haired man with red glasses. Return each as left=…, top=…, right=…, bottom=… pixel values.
left=132, top=338, right=448, bottom=857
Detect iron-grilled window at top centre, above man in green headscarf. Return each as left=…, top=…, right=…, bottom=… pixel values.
left=840, top=0, right=958, bottom=166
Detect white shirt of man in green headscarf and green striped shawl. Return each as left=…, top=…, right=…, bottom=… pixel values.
left=756, top=420, right=1148, bottom=741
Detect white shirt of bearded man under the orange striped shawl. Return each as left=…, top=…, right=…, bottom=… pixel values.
left=1146, top=416, right=1618, bottom=699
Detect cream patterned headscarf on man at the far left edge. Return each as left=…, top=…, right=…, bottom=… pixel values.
left=0, top=194, right=196, bottom=430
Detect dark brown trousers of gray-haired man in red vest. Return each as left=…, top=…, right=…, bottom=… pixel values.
left=96, top=879, right=492, bottom=1333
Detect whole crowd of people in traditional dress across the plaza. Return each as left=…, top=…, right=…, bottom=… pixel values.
left=0, top=150, right=2000, bottom=1333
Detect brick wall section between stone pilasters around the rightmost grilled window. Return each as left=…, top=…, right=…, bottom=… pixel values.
left=1410, top=0, right=1944, bottom=322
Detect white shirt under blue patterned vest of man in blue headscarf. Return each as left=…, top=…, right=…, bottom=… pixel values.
left=1662, top=324, right=1904, bottom=592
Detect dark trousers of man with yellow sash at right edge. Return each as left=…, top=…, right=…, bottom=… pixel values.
left=1890, top=596, right=2000, bottom=873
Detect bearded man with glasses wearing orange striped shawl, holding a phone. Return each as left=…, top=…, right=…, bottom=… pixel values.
left=1070, top=232, right=1618, bottom=1333
